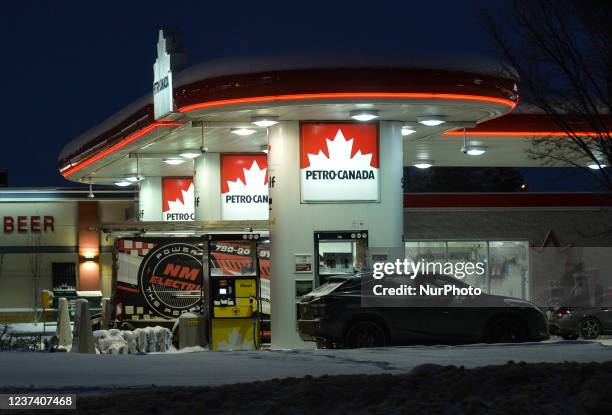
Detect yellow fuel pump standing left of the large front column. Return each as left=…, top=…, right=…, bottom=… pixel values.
left=209, top=234, right=261, bottom=350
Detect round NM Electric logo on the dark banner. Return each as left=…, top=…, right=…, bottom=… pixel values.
left=138, top=242, right=205, bottom=318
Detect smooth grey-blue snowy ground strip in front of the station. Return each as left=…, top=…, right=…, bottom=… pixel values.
left=0, top=341, right=612, bottom=389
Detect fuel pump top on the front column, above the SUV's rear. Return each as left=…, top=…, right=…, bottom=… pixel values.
left=314, top=230, right=368, bottom=286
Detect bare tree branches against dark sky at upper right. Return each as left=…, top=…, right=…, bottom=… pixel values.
left=477, top=0, right=612, bottom=190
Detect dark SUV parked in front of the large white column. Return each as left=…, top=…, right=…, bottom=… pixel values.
left=298, top=274, right=549, bottom=348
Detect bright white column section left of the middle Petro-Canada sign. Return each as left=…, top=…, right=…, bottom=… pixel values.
left=193, top=153, right=221, bottom=221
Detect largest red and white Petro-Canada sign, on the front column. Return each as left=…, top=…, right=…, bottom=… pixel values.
left=300, top=123, right=380, bottom=203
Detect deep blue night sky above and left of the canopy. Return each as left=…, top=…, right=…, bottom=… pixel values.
left=0, top=0, right=600, bottom=192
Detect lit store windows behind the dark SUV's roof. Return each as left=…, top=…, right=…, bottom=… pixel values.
left=404, top=241, right=530, bottom=299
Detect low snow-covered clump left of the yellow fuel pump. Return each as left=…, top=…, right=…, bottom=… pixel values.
left=94, top=326, right=172, bottom=354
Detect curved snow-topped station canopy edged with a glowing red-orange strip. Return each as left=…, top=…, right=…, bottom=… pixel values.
left=59, top=50, right=549, bottom=184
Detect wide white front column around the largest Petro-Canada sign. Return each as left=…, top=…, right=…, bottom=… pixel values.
left=268, top=121, right=403, bottom=348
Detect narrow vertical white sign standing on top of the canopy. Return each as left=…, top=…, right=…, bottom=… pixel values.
left=153, top=30, right=174, bottom=121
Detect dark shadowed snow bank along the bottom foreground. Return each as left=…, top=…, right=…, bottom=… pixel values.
left=45, top=362, right=612, bottom=415
